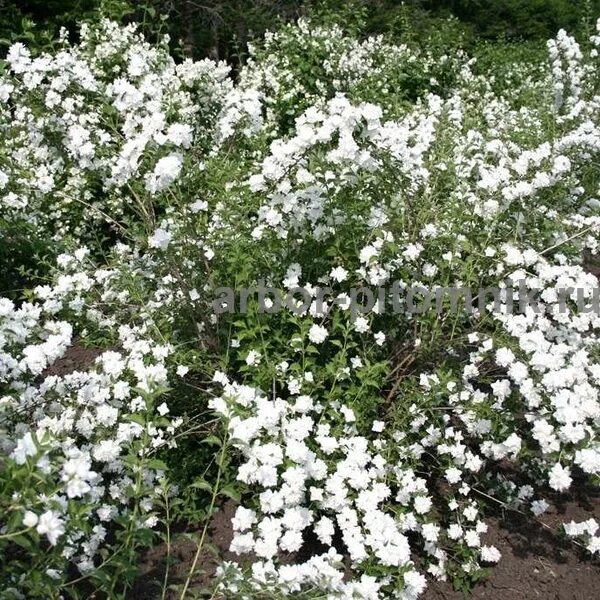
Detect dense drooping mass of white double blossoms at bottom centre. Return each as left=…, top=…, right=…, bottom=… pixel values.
left=210, top=373, right=428, bottom=600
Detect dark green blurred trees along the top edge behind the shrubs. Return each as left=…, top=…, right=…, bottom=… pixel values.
left=0, top=0, right=600, bottom=65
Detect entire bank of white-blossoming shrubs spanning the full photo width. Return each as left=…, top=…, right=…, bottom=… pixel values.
left=0, top=12, right=600, bottom=600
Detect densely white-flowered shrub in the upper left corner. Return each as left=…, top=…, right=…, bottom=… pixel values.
left=0, top=20, right=231, bottom=241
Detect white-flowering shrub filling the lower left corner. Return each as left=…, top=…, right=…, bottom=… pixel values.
left=0, top=290, right=178, bottom=598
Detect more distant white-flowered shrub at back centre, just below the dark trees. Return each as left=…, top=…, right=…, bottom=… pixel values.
left=239, top=19, right=465, bottom=133
